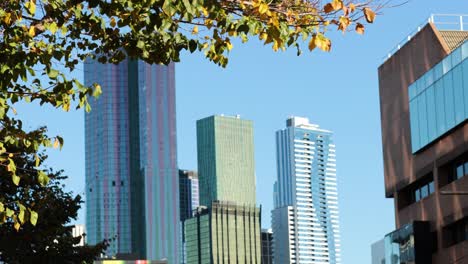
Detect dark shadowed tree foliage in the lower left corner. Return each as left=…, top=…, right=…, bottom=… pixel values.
left=0, top=128, right=108, bottom=264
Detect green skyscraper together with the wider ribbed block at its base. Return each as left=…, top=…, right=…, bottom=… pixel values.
left=185, top=116, right=261, bottom=264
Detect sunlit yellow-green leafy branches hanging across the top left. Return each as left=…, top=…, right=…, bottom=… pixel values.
left=0, top=0, right=380, bottom=229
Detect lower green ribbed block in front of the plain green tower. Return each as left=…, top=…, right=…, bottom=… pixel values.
left=185, top=202, right=262, bottom=264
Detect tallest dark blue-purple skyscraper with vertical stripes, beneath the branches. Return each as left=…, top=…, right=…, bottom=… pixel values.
left=84, top=60, right=180, bottom=263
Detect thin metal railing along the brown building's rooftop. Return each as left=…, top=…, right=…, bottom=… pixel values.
left=382, top=14, right=468, bottom=62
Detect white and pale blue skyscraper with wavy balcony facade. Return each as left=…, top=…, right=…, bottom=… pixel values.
left=272, top=117, right=341, bottom=264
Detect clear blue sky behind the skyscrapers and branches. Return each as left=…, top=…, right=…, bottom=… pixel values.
left=18, top=0, right=468, bottom=264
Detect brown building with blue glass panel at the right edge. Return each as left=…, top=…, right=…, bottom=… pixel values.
left=379, top=16, right=468, bottom=264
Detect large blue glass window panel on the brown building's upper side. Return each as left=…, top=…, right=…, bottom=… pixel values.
left=408, top=41, right=468, bottom=153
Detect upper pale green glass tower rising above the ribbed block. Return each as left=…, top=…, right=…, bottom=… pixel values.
left=197, top=115, right=255, bottom=206
